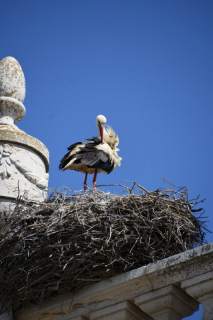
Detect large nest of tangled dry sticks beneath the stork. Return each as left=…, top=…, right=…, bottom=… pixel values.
left=0, top=186, right=204, bottom=308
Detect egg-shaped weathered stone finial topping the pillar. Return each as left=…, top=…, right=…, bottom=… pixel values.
left=0, top=57, right=26, bottom=125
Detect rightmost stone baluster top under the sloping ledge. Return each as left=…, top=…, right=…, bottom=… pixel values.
left=181, top=272, right=213, bottom=320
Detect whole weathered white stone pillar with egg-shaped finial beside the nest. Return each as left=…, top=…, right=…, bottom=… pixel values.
left=0, top=57, right=49, bottom=211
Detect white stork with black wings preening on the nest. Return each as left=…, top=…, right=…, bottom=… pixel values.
left=59, top=115, right=122, bottom=191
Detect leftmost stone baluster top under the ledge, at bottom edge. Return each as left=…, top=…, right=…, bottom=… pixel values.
left=90, top=301, right=152, bottom=320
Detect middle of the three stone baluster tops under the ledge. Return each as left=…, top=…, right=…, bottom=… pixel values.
left=135, top=285, right=198, bottom=320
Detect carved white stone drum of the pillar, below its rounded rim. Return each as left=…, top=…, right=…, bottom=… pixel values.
left=0, top=142, right=48, bottom=201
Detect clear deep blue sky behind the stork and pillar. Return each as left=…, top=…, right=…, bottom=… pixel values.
left=0, top=0, right=213, bottom=319
